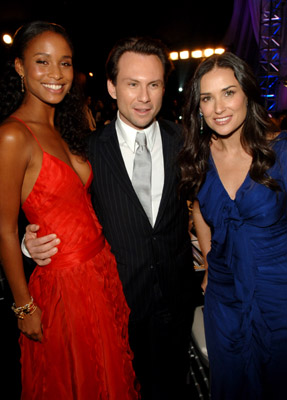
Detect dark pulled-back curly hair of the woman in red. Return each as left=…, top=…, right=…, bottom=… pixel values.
left=0, top=21, right=88, bottom=158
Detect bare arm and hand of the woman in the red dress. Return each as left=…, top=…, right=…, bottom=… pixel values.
left=0, top=123, right=42, bottom=340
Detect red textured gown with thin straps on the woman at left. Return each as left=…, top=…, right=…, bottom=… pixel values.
left=17, top=118, right=139, bottom=400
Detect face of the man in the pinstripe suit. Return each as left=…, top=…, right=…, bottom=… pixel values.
left=108, top=52, right=164, bottom=129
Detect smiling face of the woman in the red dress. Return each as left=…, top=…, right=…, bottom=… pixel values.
left=15, top=31, right=73, bottom=104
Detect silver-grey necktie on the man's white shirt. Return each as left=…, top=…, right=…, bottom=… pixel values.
left=132, top=131, right=153, bottom=225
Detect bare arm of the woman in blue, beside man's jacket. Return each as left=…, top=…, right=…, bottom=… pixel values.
left=193, top=200, right=211, bottom=292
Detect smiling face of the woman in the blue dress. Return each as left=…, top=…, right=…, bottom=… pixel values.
left=200, top=67, right=247, bottom=136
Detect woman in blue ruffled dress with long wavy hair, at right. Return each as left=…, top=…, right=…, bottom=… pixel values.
left=179, top=52, right=287, bottom=400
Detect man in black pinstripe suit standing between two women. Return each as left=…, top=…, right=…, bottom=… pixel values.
left=24, top=38, right=197, bottom=400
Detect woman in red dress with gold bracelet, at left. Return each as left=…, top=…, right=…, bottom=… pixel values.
left=0, top=21, right=138, bottom=400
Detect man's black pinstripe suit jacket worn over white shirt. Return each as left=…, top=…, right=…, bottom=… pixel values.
left=89, top=121, right=194, bottom=320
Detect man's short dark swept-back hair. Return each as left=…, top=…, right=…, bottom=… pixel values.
left=106, top=37, right=174, bottom=85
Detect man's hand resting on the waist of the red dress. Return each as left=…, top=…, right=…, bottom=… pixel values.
left=25, top=225, right=60, bottom=266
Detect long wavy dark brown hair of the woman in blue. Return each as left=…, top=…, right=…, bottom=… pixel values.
left=178, top=52, right=281, bottom=201
